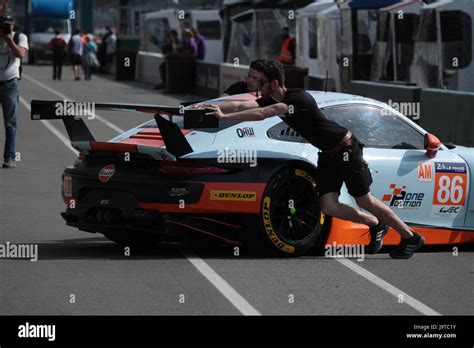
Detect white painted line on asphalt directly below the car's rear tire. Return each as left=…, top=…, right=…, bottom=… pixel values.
left=181, top=250, right=262, bottom=315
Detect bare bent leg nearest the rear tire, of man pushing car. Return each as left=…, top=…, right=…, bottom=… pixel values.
left=319, top=192, right=378, bottom=227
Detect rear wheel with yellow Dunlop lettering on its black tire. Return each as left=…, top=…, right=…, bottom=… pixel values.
left=257, top=164, right=325, bottom=257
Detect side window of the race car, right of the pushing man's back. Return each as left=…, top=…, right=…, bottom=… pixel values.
left=322, top=105, right=424, bottom=150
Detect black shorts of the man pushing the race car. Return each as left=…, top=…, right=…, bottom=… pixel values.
left=317, top=139, right=372, bottom=197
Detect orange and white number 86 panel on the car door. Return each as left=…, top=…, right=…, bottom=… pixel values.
left=431, top=162, right=467, bottom=218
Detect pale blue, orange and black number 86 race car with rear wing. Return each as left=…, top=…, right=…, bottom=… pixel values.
left=31, top=91, right=474, bottom=256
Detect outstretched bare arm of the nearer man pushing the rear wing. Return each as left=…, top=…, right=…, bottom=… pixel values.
left=206, top=102, right=288, bottom=121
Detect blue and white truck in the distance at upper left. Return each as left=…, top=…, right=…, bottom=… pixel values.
left=25, top=0, right=75, bottom=64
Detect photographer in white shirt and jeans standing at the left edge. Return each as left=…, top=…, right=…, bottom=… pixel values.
left=0, top=16, right=28, bottom=168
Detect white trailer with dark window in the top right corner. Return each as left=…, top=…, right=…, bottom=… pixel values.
left=410, top=0, right=474, bottom=92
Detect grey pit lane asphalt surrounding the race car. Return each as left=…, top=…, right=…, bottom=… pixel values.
left=0, top=66, right=474, bottom=315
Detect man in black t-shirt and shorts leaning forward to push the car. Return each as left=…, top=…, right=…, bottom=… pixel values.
left=206, top=61, right=424, bottom=259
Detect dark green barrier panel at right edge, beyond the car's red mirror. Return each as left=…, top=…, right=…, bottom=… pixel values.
left=419, top=88, right=474, bottom=147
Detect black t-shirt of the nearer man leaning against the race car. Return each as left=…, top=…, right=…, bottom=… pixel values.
left=257, top=89, right=347, bottom=151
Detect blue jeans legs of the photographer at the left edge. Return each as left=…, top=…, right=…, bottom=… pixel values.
left=0, top=81, right=19, bottom=162
